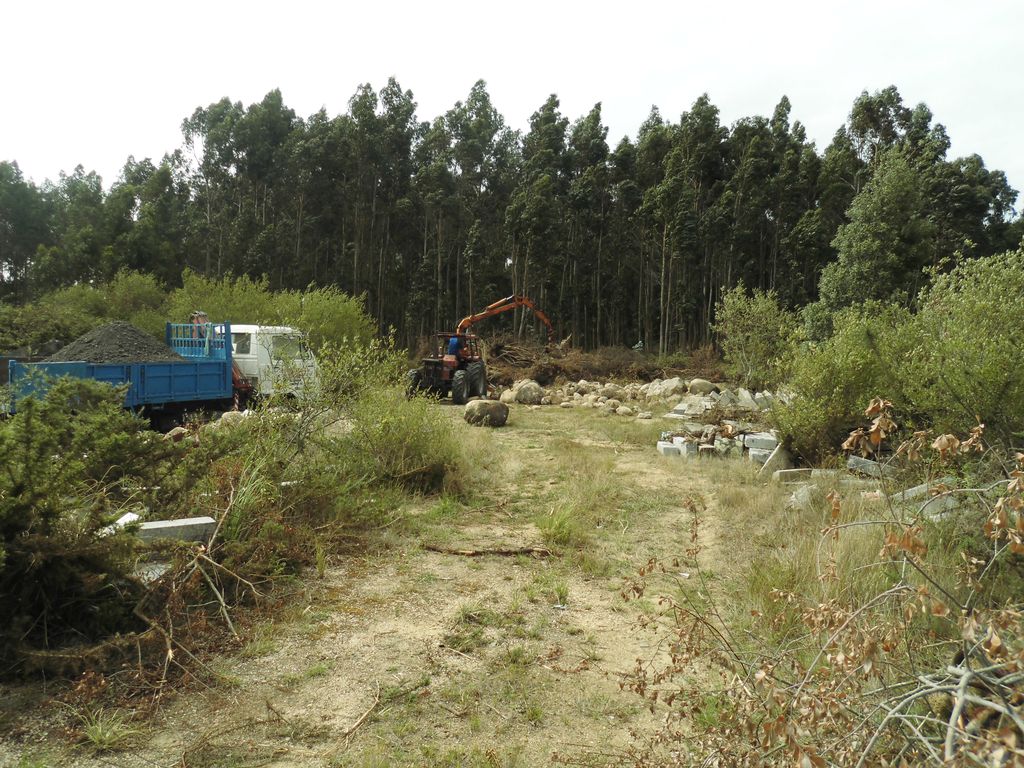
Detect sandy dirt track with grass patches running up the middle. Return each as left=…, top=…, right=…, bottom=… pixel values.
left=0, top=407, right=757, bottom=768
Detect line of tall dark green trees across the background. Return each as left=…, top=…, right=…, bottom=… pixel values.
left=0, top=79, right=1024, bottom=351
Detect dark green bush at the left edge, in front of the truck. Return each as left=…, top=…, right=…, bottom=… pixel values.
left=0, top=379, right=179, bottom=663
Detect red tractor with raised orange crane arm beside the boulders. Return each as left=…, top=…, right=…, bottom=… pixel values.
left=408, top=296, right=555, bottom=406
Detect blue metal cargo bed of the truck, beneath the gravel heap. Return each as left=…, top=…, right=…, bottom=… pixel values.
left=8, top=323, right=241, bottom=431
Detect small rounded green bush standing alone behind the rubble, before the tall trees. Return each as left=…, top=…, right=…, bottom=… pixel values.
left=714, top=285, right=798, bottom=388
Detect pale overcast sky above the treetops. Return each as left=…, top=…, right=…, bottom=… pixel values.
left=0, top=0, right=1024, bottom=207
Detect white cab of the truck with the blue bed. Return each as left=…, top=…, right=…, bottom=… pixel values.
left=231, top=323, right=316, bottom=396
